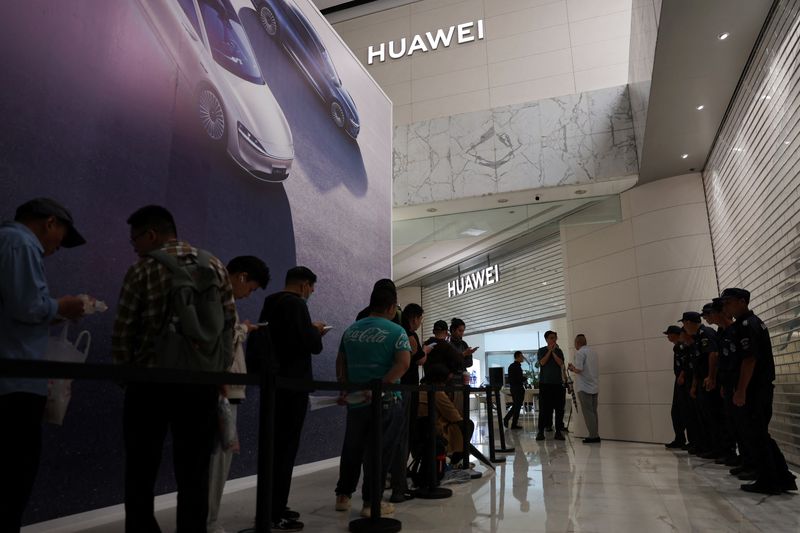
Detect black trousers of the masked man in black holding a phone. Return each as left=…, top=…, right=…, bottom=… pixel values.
left=272, top=389, right=308, bottom=521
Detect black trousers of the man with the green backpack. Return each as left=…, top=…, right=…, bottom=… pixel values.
left=122, top=383, right=219, bottom=533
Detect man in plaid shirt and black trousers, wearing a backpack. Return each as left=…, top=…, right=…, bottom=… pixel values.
left=111, top=206, right=236, bottom=533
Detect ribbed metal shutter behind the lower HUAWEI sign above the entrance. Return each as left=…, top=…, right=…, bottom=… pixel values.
left=422, top=235, right=566, bottom=336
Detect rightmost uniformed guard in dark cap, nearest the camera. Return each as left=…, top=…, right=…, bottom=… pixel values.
left=720, top=288, right=797, bottom=494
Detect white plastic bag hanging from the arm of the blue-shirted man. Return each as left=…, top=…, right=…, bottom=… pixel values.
left=44, top=323, right=92, bottom=426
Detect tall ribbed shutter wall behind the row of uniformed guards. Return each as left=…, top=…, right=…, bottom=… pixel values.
left=704, top=0, right=800, bottom=464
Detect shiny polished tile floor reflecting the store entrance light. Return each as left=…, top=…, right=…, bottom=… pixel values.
left=79, top=417, right=800, bottom=533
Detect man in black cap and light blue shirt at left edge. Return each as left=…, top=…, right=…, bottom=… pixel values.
left=0, top=198, right=86, bottom=532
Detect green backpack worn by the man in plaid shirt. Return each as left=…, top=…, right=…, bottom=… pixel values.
left=147, top=250, right=234, bottom=372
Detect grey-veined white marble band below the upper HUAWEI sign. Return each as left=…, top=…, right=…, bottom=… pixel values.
left=394, top=85, right=638, bottom=206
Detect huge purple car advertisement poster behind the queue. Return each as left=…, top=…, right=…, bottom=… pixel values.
left=0, top=0, right=391, bottom=523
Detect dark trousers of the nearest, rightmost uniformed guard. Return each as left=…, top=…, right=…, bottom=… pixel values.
left=737, top=383, right=791, bottom=486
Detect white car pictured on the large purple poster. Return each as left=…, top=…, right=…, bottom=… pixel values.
left=138, top=0, right=294, bottom=181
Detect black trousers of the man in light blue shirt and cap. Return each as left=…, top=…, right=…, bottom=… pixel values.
left=0, top=392, right=47, bottom=533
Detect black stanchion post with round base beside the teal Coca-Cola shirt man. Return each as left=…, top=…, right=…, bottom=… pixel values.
left=350, top=379, right=402, bottom=533
